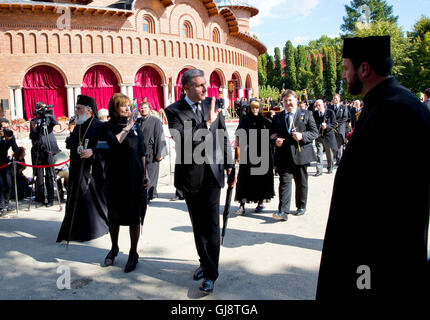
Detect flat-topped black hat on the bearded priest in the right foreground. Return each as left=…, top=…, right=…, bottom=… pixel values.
left=342, top=36, right=391, bottom=60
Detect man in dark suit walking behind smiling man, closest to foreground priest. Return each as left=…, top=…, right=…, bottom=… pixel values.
left=313, top=100, right=337, bottom=177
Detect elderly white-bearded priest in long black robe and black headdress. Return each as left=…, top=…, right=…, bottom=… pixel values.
left=57, top=95, right=109, bottom=242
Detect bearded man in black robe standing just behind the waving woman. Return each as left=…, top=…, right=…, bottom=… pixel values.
left=136, top=101, right=168, bottom=201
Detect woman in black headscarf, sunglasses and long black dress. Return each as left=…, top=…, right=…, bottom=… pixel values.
left=235, top=101, right=275, bottom=215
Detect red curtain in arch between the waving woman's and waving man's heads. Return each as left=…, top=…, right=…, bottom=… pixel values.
left=133, top=66, right=164, bottom=111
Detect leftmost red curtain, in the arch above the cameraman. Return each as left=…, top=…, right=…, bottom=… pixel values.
left=22, top=66, right=67, bottom=119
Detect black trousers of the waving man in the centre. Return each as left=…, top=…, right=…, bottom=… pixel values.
left=184, top=165, right=221, bottom=281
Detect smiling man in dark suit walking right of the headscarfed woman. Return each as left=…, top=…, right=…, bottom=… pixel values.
left=271, top=90, right=318, bottom=221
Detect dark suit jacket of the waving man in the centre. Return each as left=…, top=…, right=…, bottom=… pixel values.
left=165, top=99, right=233, bottom=192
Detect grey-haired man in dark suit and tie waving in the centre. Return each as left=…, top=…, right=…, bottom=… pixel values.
left=166, top=69, right=233, bottom=293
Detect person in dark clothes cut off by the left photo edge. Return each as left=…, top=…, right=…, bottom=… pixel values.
left=0, top=118, right=18, bottom=216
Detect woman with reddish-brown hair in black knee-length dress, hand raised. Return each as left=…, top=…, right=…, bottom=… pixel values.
left=104, top=93, right=149, bottom=272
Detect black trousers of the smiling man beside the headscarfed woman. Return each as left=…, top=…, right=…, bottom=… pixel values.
left=278, top=161, right=308, bottom=212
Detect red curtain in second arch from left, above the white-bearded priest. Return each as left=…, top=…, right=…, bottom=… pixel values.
left=81, top=65, right=120, bottom=109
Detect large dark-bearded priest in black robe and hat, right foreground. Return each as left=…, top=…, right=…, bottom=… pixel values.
left=316, top=37, right=430, bottom=303
